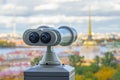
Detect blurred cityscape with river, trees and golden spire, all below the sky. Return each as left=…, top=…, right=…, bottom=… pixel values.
left=0, top=16, right=120, bottom=80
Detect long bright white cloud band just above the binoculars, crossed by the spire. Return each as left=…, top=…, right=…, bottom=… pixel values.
left=0, top=15, right=120, bottom=27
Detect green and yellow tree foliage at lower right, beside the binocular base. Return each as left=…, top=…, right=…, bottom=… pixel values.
left=70, top=52, right=120, bottom=80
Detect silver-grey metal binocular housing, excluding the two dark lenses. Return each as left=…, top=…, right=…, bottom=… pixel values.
left=23, top=26, right=77, bottom=46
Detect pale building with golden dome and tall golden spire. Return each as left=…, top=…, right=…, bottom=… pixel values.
left=80, top=9, right=101, bottom=62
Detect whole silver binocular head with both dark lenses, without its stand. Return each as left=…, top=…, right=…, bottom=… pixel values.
left=23, top=26, right=77, bottom=46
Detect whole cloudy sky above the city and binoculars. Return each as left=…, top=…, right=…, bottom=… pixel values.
left=0, top=0, right=120, bottom=34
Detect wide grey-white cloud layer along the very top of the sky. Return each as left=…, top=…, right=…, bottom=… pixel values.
left=0, top=0, right=120, bottom=16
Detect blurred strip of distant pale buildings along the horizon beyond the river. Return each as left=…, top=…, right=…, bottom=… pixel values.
left=0, top=32, right=120, bottom=47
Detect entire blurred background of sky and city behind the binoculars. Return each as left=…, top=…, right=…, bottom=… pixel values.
left=0, top=0, right=120, bottom=80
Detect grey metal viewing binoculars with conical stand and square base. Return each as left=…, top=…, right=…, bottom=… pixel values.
left=23, top=26, right=77, bottom=80
